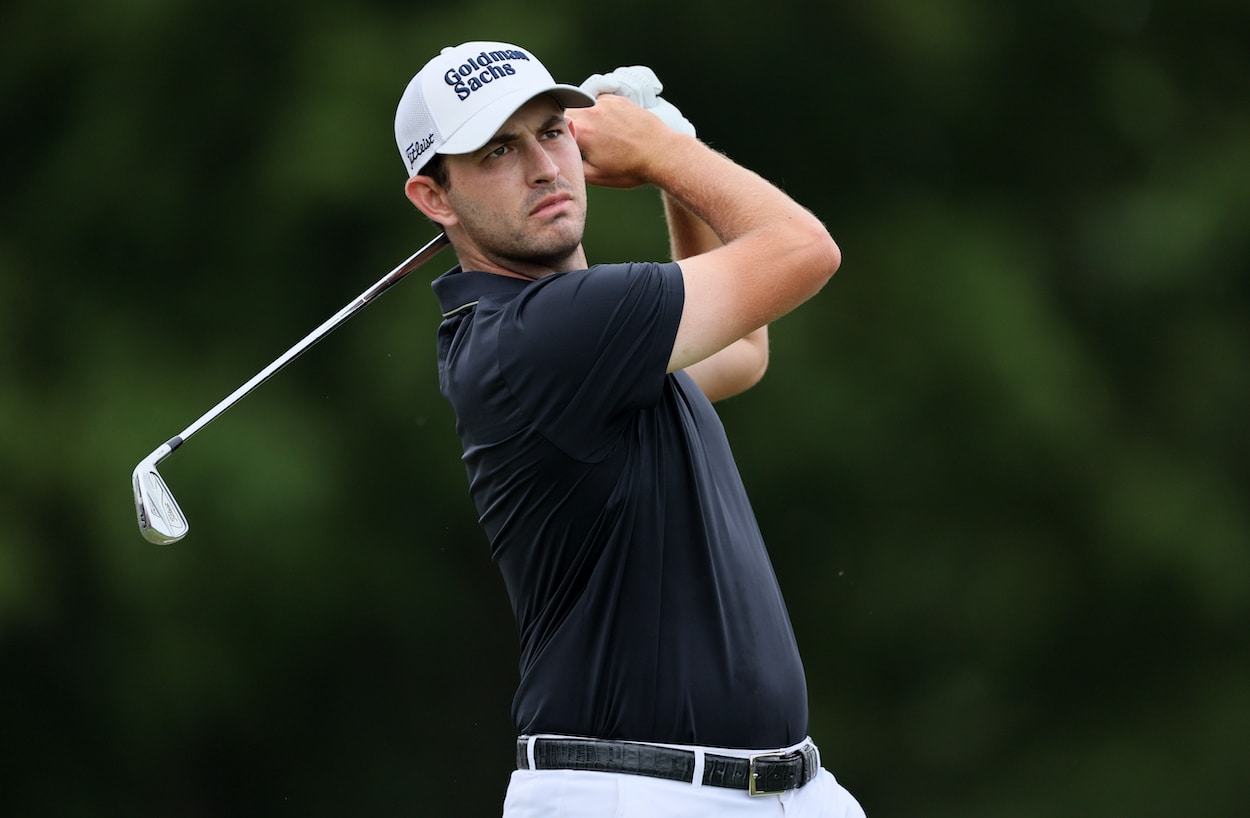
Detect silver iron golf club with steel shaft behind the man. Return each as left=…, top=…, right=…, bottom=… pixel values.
left=133, top=233, right=448, bottom=545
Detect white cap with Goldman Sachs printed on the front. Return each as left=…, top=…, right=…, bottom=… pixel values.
left=395, top=43, right=595, bottom=178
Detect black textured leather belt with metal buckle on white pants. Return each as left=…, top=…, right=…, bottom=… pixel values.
left=516, top=738, right=820, bottom=795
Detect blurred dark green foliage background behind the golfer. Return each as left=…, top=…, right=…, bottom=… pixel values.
left=0, top=0, right=1250, bottom=818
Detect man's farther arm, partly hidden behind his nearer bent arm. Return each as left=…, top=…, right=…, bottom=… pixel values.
left=664, top=194, right=769, bottom=401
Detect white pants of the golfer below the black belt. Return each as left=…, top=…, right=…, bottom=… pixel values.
left=504, top=745, right=865, bottom=818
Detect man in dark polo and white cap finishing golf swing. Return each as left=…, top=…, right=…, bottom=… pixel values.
left=395, top=43, right=863, bottom=818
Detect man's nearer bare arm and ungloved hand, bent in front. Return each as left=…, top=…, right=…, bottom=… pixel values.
left=568, top=95, right=841, bottom=371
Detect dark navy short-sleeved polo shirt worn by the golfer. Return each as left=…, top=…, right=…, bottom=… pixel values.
left=434, top=264, right=808, bottom=748
